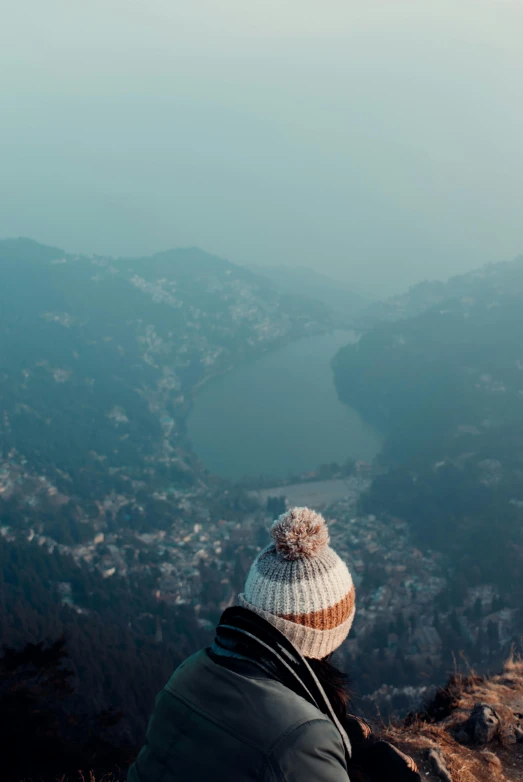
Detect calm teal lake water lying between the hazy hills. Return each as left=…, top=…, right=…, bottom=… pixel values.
left=188, top=332, right=382, bottom=480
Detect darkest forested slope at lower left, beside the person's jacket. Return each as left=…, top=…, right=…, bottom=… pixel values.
left=0, top=538, right=208, bottom=780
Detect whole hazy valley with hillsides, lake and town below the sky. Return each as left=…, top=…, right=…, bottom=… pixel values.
left=0, top=240, right=523, bottom=764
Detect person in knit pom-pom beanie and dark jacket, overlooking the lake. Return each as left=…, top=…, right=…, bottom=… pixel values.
left=128, top=508, right=420, bottom=782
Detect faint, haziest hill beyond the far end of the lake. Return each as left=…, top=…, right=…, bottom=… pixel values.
left=248, top=266, right=370, bottom=323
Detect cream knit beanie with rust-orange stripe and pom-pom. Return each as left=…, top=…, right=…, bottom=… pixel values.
left=239, top=508, right=356, bottom=659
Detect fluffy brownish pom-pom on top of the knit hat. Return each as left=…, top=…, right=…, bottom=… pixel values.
left=271, top=508, right=330, bottom=560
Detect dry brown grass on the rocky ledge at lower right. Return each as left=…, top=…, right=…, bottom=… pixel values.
left=385, top=656, right=523, bottom=782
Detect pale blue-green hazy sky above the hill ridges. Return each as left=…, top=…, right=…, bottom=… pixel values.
left=0, top=0, right=523, bottom=292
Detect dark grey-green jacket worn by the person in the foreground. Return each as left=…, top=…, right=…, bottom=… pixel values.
left=128, top=608, right=418, bottom=782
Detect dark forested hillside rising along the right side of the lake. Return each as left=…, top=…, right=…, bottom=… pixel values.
left=334, top=254, right=523, bottom=605
